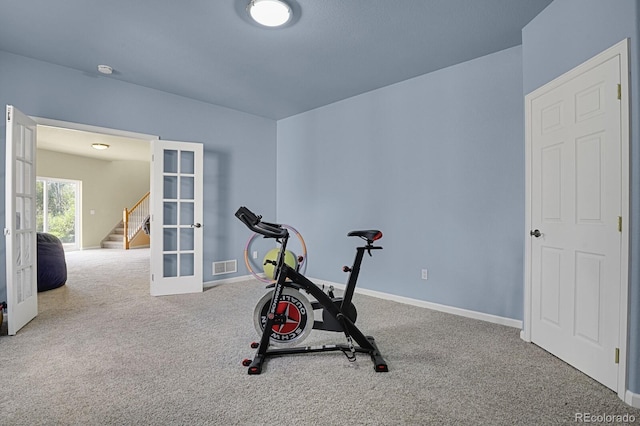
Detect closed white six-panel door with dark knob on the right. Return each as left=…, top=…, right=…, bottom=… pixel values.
left=527, top=43, right=628, bottom=391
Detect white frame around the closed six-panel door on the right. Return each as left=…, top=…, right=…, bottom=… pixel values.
left=520, top=39, right=630, bottom=403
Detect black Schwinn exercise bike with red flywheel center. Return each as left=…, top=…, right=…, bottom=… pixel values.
left=236, top=207, right=389, bottom=374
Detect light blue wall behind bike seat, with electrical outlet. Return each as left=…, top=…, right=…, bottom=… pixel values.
left=277, top=47, right=524, bottom=320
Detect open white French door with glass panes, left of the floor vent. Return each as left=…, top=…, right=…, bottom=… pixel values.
left=151, top=140, right=203, bottom=296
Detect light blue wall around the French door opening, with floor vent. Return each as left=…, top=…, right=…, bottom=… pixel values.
left=0, top=52, right=276, bottom=301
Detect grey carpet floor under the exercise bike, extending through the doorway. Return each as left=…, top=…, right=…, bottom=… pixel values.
left=0, top=249, right=640, bottom=425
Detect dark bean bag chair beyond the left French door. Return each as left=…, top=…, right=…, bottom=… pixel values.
left=38, top=232, right=67, bottom=292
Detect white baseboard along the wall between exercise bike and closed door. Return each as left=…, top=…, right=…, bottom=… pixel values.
left=311, top=279, right=522, bottom=329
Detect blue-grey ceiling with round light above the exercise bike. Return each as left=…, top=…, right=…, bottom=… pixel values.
left=0, top=0, right=552, bottom=120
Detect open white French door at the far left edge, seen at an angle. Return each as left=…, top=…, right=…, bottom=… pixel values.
left=4, top=105, right=38, bottom=335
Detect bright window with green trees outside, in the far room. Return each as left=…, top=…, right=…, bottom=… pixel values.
left=36, top=177, right=81, bottom=250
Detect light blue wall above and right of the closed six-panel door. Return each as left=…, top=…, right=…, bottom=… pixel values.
left=522, top=0, right=640, bottom=393
